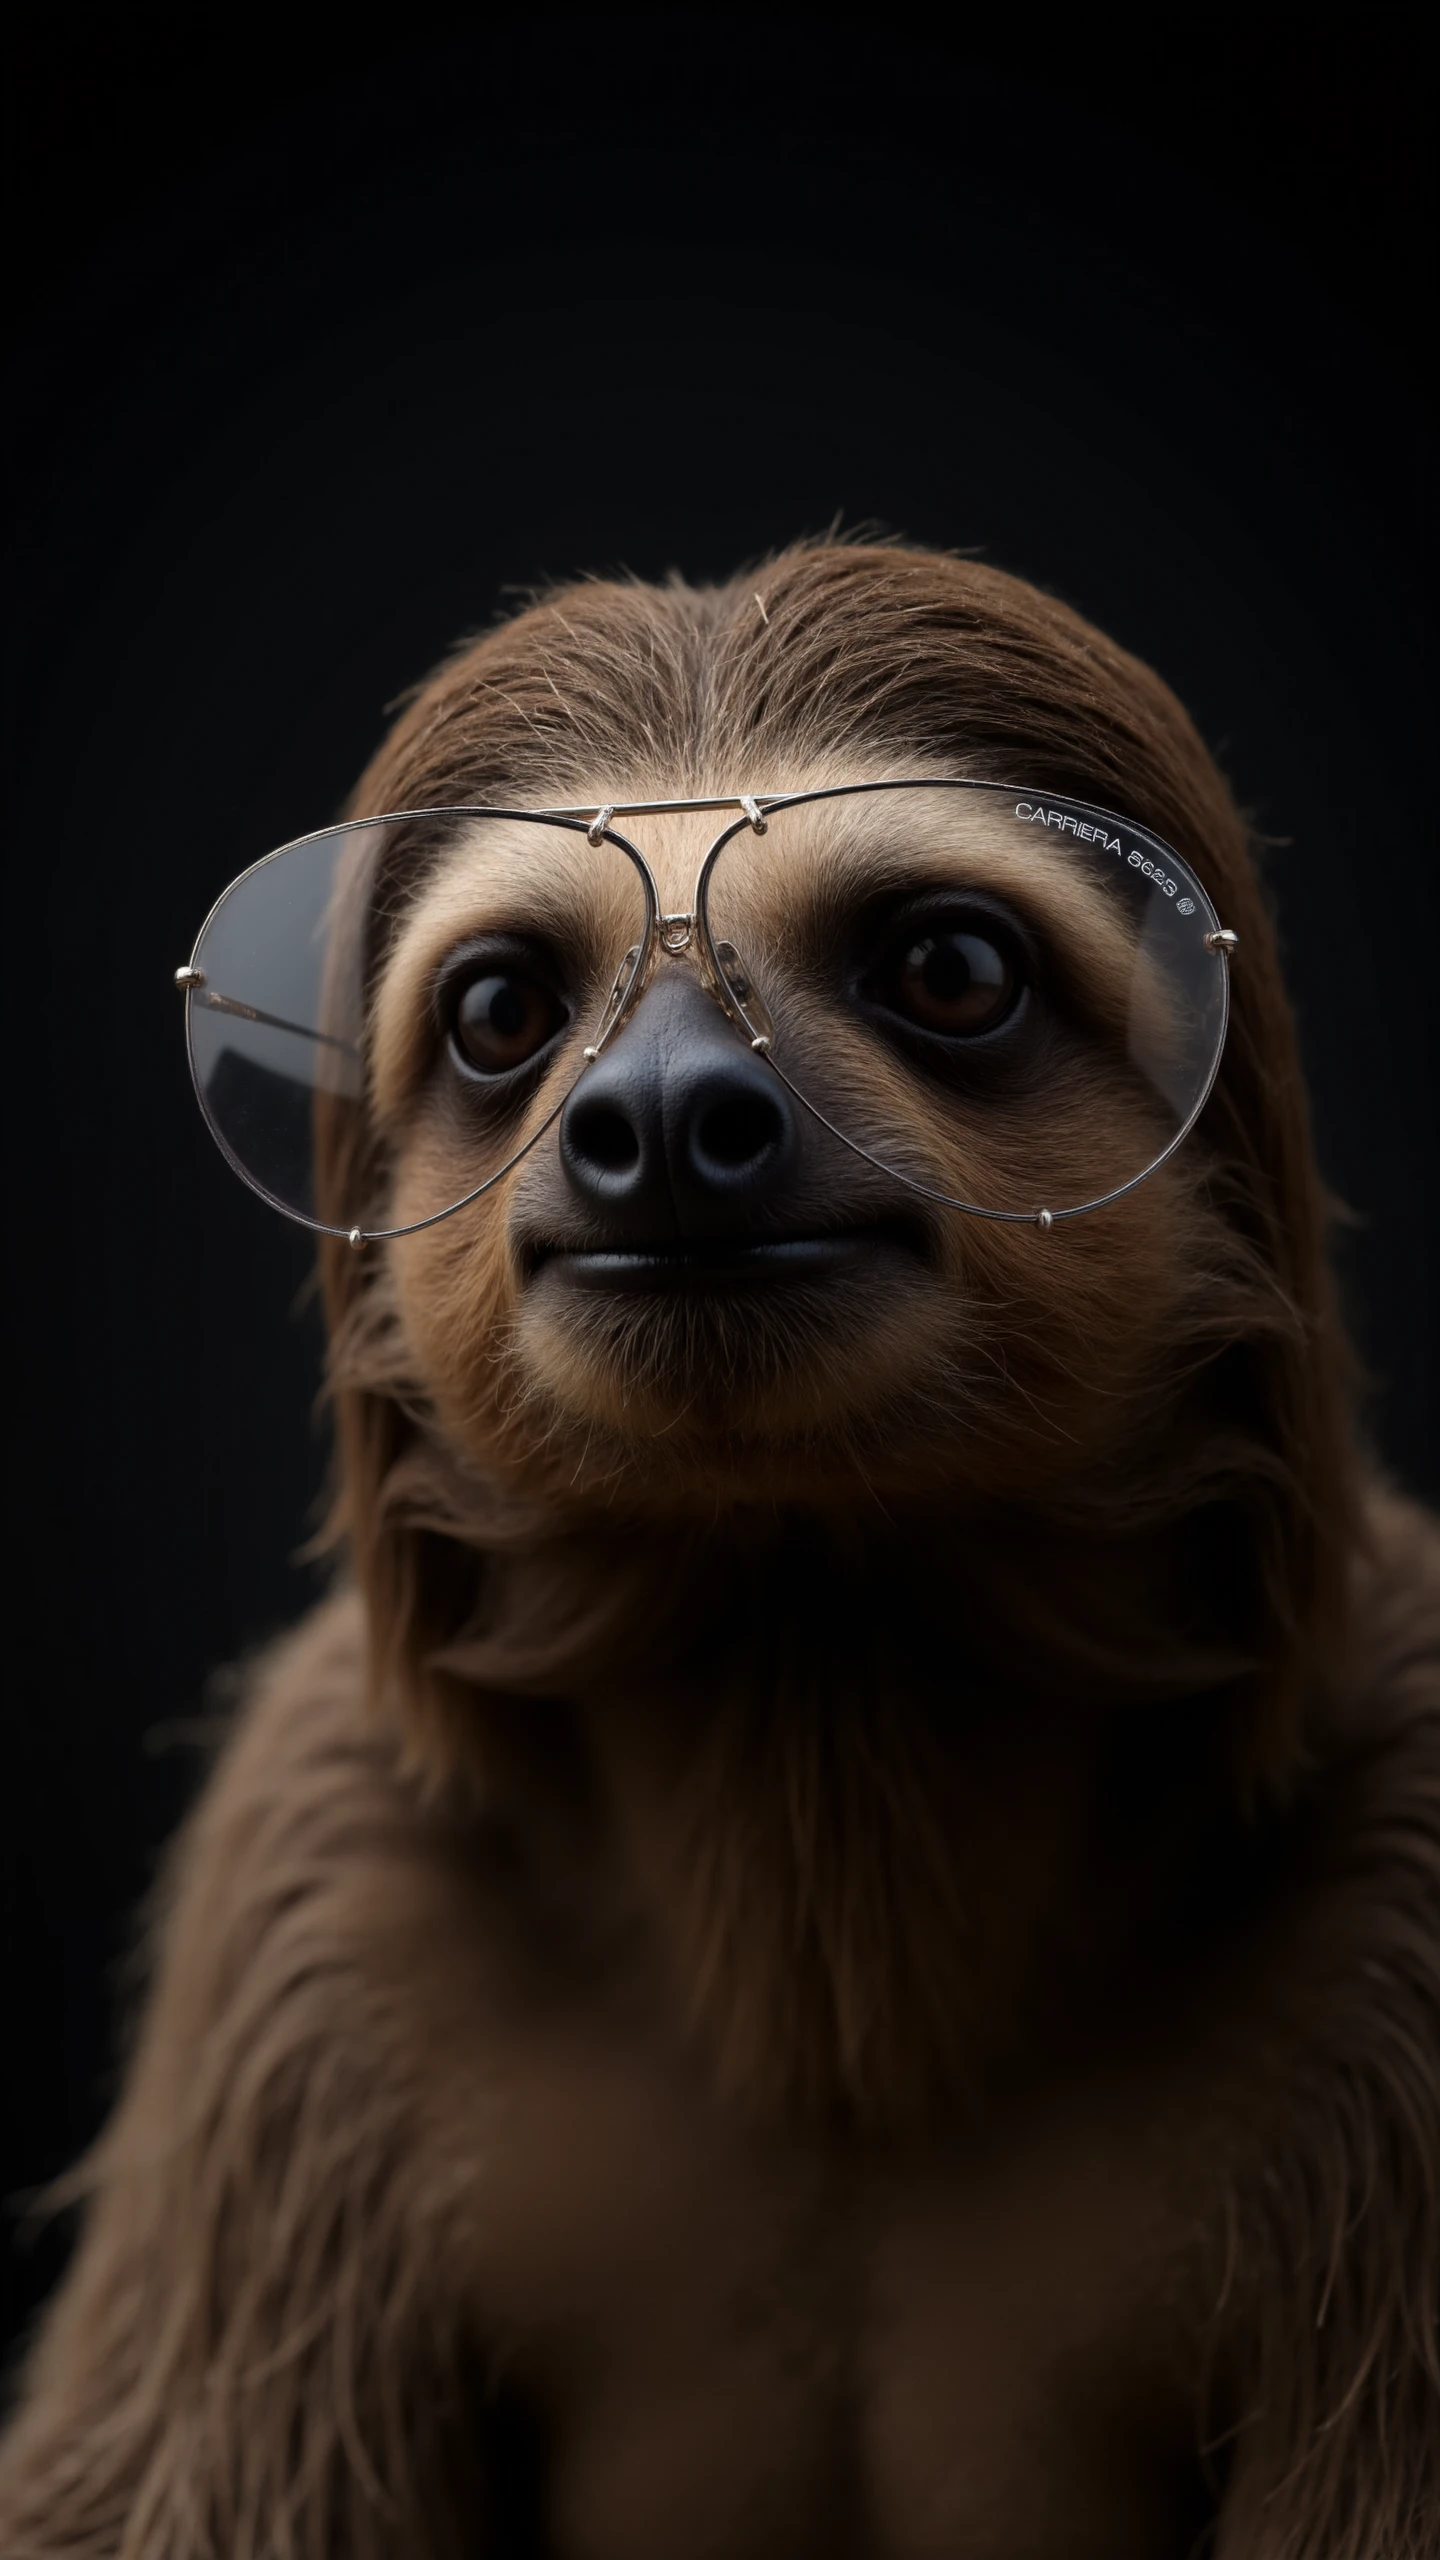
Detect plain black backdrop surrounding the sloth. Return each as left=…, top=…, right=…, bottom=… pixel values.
left=0, top=8, right=1440, bottom=2327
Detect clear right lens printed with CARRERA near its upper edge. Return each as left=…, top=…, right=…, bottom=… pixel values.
left=707, top=783, right=1227, bottom=1216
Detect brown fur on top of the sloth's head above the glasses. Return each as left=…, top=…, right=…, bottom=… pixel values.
left=356, top=543, right=1235, bottom=855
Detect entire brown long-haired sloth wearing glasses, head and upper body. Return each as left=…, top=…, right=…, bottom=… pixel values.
left=0, top=543, right=1440, bottom=2560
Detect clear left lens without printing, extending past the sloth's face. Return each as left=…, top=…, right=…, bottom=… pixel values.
left=187, top=812, right=646, bottom=1234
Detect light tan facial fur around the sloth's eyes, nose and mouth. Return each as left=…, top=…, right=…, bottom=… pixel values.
left=377, top=788, right=1188, bottom=1516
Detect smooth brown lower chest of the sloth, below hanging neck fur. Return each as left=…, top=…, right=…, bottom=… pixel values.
left=471, top=2056, right=1204, bottom=2560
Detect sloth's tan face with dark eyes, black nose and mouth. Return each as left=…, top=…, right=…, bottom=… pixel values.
left=363, top=776, right=1194, bottom=1505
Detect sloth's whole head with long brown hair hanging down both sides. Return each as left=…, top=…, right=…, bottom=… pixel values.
left=316, top=545, right=1350, bottom=1759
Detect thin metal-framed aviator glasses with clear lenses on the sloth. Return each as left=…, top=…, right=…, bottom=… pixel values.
left=174, top=781, right=1238, bottom=1247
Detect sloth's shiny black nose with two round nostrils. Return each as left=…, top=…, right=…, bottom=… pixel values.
left=561, top=965, right=794, bottom=1244
